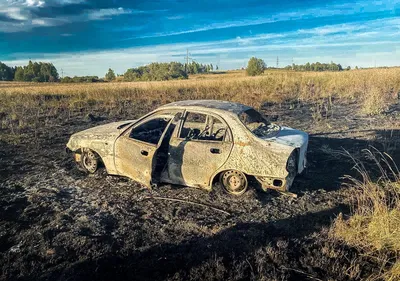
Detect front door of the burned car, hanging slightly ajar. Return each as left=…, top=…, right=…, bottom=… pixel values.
left=114, top=113, right=174, bottom=186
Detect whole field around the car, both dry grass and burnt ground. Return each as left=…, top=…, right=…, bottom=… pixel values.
left=0, top=68, right=400, bottom=281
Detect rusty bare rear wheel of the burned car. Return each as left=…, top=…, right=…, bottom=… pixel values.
left=219, top=170, right=248, bottom=196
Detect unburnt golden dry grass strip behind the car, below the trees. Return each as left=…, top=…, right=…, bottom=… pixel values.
left=0, top=68, right=400, bottom=137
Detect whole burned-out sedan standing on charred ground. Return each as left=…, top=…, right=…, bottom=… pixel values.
left=67, top=100, right=308, bottom=195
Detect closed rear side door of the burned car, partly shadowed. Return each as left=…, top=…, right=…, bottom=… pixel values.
left=168, top=111, right=233, bottom=187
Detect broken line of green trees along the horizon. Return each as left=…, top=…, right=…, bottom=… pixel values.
left=0, top=57, right=350, bottom=83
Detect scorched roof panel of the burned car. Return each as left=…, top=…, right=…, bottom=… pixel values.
left=161, top=100, right=251, bottom=114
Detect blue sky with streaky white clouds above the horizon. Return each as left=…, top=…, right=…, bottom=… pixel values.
left=0, top=0, right=400, bottom=77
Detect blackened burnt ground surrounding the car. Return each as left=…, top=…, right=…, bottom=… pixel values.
left=0, top=99, right=400, bottom=280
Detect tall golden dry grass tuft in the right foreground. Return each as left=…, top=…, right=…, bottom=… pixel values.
left=331, top=149, right=400, bottom=281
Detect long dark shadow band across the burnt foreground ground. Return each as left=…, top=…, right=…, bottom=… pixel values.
left=40, top=205, right=348, bottom=280
